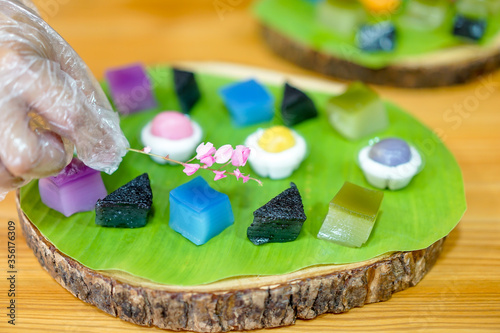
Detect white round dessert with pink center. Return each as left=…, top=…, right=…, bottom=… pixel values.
left=141, top=111, right=203, bottom=164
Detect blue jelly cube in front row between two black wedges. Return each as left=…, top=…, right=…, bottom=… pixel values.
left=169, top=177, right=234, bottom=245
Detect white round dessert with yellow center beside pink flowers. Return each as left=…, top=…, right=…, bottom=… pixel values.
left=245, top=126, right=307, bottom=179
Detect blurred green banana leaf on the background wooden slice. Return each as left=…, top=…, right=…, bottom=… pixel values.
left=254, top=0, right=500, bottom=69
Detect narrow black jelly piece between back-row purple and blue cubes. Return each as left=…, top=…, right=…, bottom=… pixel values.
left=173, top=68, right=201, bottom=113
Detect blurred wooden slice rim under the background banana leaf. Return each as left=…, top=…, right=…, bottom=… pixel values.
left=261, top=25, right=500, bottom=88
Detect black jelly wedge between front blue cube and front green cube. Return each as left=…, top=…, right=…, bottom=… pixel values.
left=247, top=183, right=307, bottom=245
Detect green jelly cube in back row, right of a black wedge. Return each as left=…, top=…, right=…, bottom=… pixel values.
left=326, top=82, right=389, bottom=140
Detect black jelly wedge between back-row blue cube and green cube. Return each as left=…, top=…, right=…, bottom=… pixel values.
left=281, top=83, right=318, bottom=126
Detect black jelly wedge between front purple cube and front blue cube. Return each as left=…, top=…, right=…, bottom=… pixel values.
left=95, top=173, right=153, bottom=228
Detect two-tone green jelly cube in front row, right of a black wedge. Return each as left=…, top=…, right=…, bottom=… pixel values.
left=318, top=182, right=384, bottom=247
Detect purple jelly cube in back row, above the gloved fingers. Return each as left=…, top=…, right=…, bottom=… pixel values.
left=106, top=64, right=158, bottom=114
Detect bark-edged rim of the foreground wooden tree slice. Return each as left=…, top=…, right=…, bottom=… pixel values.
left=17, top=193, right=444, bottom=332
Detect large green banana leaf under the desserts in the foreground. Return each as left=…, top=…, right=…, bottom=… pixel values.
left=21, top=67, right=466, bottom=285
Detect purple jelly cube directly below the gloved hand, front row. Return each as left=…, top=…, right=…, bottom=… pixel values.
left=38, top=158, right=108, bottom=216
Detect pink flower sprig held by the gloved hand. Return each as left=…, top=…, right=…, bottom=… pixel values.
left=129, top=142, right=262, bottom=186
